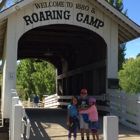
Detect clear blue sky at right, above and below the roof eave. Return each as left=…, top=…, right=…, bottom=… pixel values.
left=123, top=0, right=140, bottom=58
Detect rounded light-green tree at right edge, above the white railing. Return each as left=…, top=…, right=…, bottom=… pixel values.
left=118, top=57, right=140, bottom=94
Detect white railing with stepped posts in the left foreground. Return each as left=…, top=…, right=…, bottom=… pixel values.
left=9, top=89, right=31, bottom=140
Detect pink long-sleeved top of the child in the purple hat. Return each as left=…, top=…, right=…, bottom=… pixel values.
left=79, top=105, right=98, bottom=121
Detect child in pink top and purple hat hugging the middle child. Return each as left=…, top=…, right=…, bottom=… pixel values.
left=79, top=98, right=100, bottom=140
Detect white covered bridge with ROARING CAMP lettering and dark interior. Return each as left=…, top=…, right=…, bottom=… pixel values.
left=0, top=0, right=140, bottom=125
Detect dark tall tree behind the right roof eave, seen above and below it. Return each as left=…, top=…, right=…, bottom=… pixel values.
left=106, top=0, right=127, bottom=71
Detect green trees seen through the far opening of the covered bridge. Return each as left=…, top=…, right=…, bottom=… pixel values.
left=17, top=59, right=56, bottom=100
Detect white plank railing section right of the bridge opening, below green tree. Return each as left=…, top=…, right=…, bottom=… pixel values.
left=106, top=91, right=140, bottom=131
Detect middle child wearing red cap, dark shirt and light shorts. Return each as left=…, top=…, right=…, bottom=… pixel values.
left=78, top=89, right=89, bottom=140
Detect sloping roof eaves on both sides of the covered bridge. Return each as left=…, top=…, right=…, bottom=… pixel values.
left=0, top=0, right=140, bottom=58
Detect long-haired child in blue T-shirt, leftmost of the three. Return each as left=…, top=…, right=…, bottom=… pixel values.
left=67, top=96, right=79, bottom=140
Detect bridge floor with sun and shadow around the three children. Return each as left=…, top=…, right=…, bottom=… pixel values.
left=26, top=108, right=140, bottom=140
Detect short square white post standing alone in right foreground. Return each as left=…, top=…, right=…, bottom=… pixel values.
left=103, top=116, right=118, bottom=140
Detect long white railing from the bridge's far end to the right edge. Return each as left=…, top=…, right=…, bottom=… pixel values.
left=44, top=91, right=140, bottom=131
